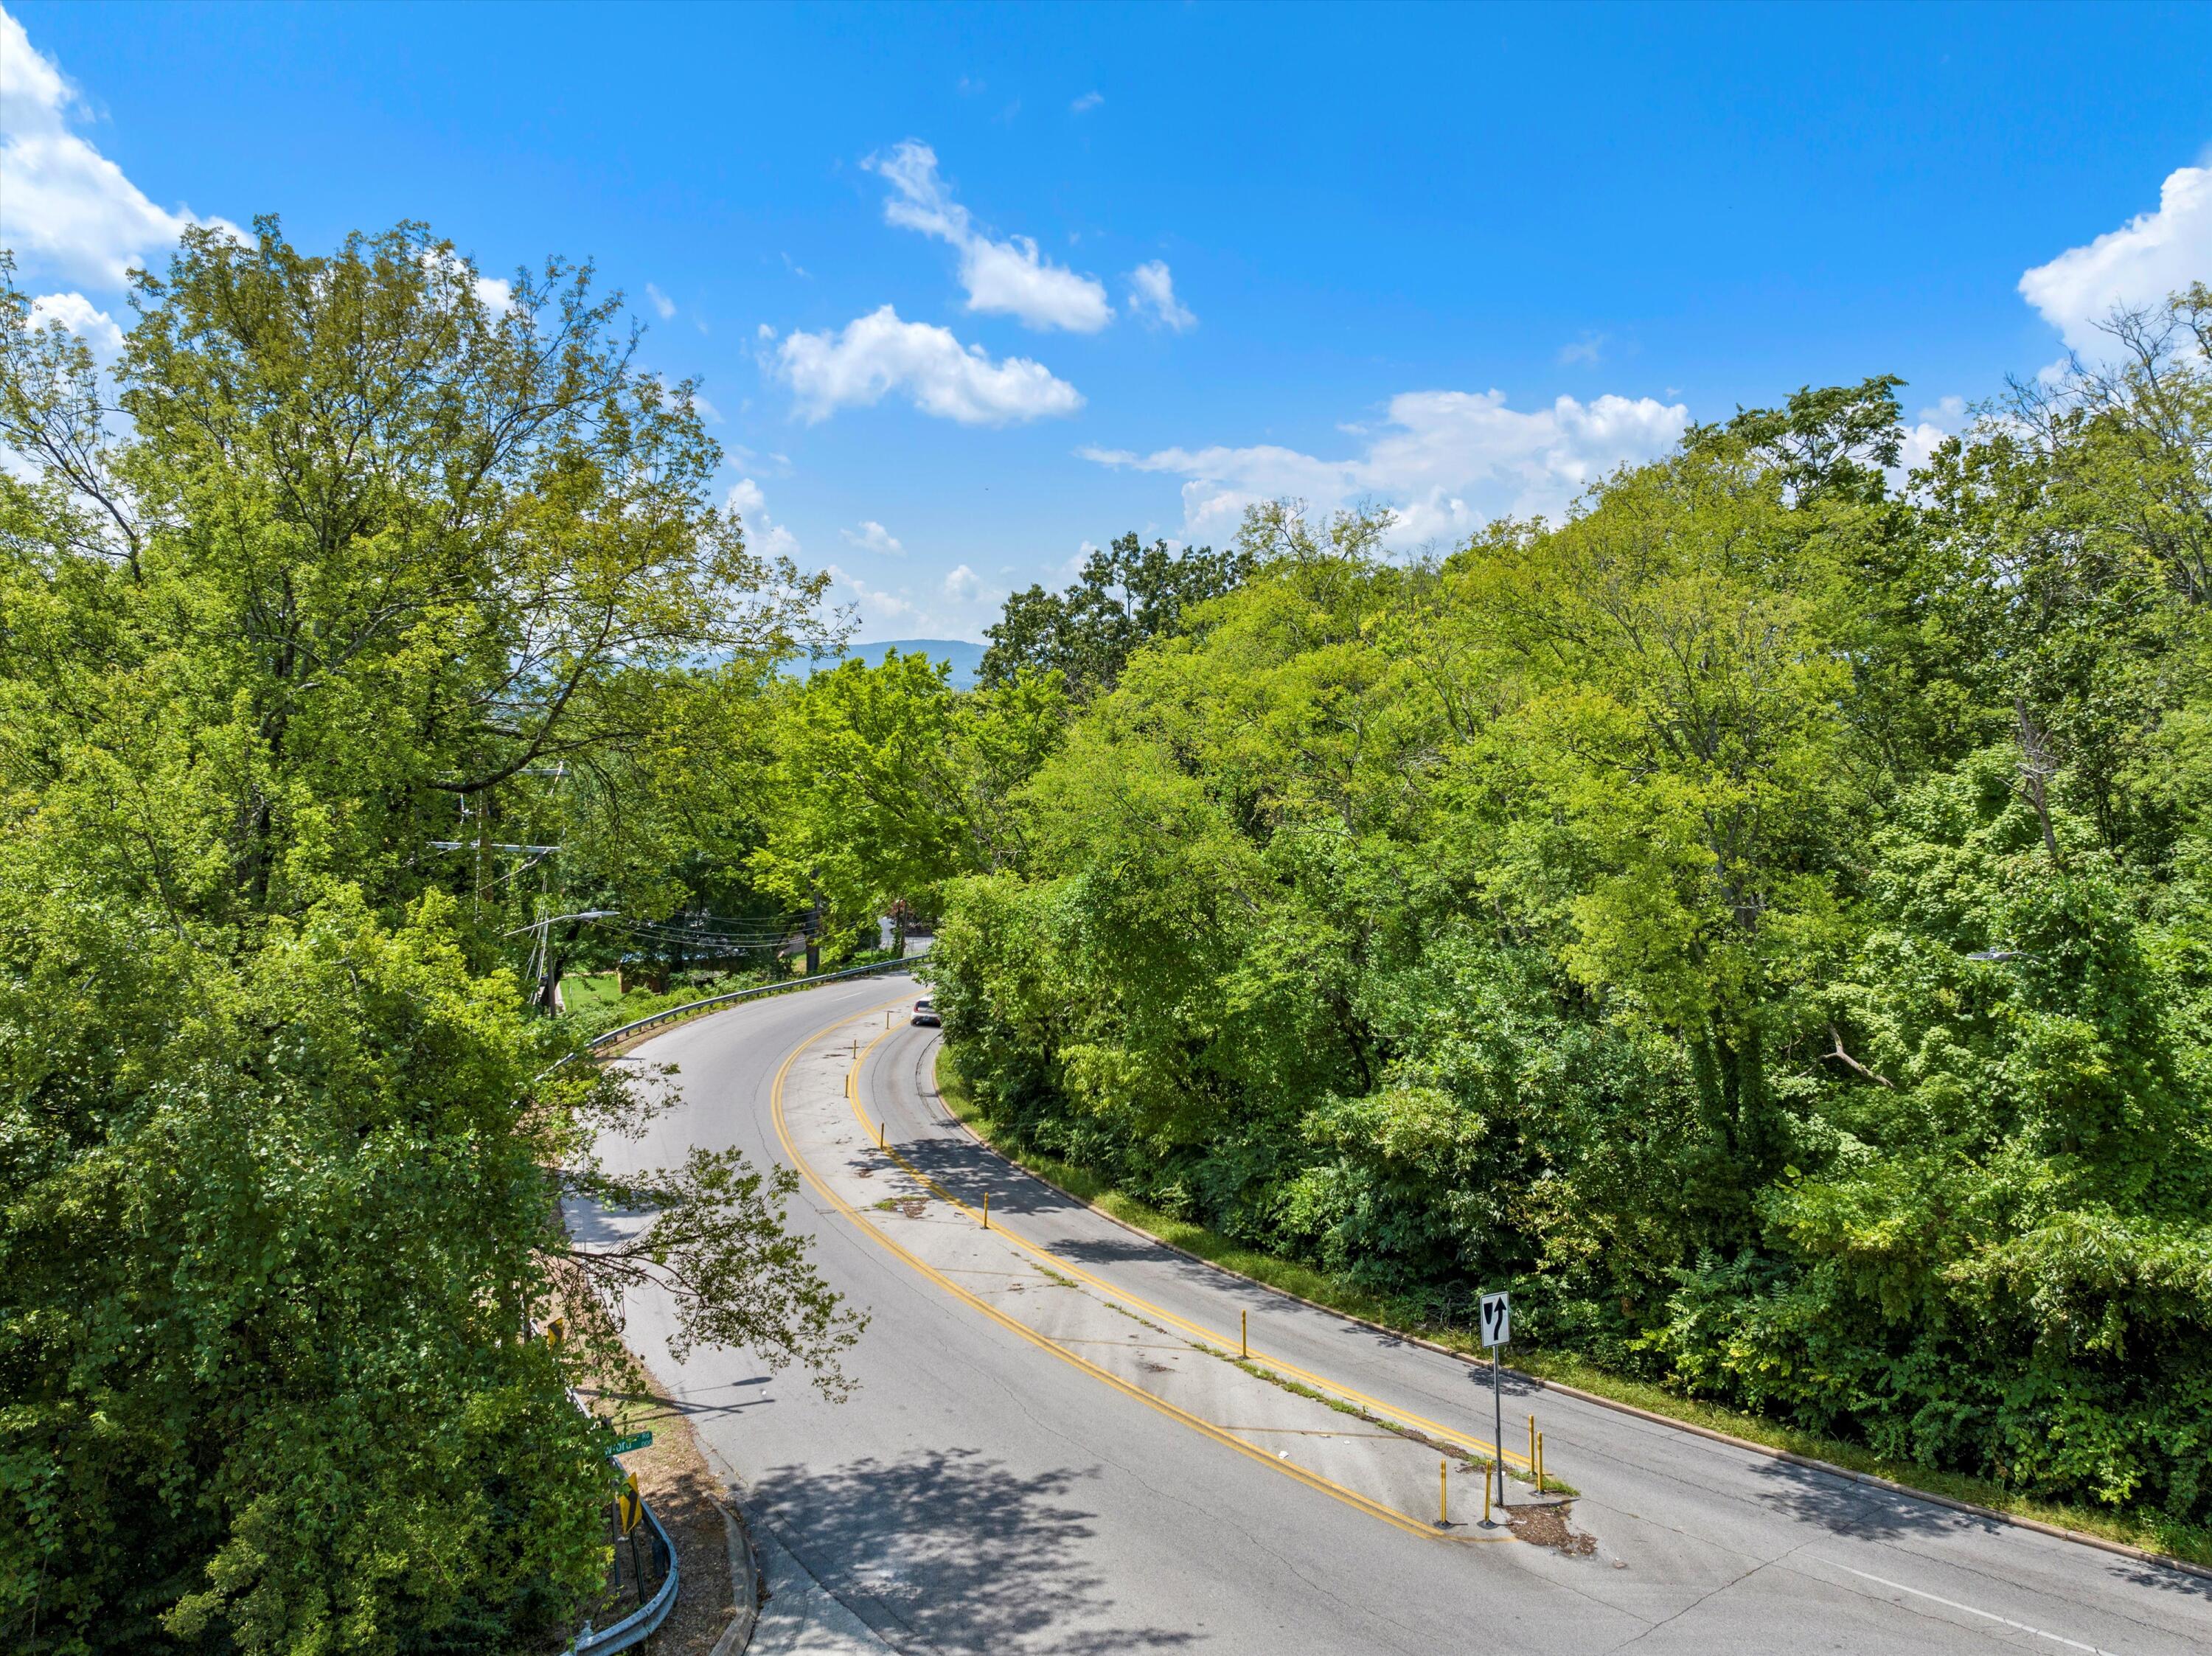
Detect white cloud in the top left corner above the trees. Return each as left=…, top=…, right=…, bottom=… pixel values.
left=0, top=11, right=239, bottom=288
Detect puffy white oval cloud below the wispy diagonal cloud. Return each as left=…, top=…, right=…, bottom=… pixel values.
left=774, top=305, right=1084, bottom=425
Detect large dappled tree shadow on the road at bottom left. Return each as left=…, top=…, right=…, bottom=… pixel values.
left=745, top=1450, right=1197, bottom=1656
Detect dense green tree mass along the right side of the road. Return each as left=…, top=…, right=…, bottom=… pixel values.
left=936, top=300, right=2212, bottom=1525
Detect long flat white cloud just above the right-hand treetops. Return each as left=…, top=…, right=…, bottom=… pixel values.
left=1082, top=392, right=1690, bottom=546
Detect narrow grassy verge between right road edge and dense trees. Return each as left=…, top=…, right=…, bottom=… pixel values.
left=938, top=1063, right=2212, bottom=1568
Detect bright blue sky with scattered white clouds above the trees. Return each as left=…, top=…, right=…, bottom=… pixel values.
left=0, top=0, right=2212, bottom=639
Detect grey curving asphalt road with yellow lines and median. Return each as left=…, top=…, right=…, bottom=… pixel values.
left=573, top=977, right=2212, bottom=1656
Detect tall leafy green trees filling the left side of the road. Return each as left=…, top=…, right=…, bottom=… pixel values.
left=0, top=223, right=852, bottom=1656
